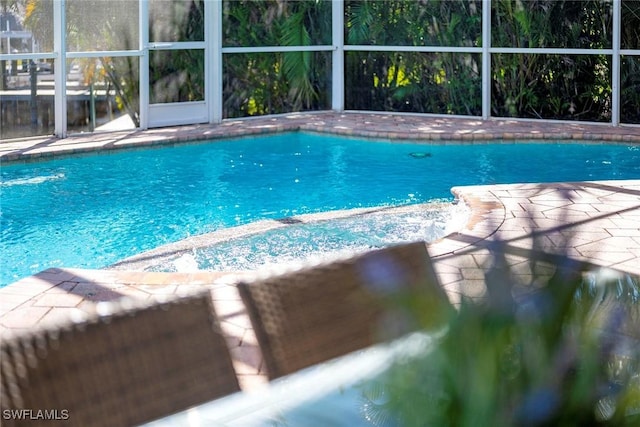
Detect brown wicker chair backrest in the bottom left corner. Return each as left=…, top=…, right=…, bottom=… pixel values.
left=0, top=292, right=239, bottom=426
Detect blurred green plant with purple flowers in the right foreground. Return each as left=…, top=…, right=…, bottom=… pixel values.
left=362, top=251, right=640, bottom=427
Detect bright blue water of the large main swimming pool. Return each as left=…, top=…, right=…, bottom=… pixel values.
left=0, top=133, right=640, bottom=286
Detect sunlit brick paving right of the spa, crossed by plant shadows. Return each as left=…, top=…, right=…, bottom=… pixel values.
left=436, top=180, right=640, bottom=298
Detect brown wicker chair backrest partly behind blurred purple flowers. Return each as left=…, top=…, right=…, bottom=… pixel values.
left=238, top=242, right=453, bottom=379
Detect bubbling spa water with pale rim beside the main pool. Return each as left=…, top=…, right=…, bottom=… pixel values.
left=141, top=202, right=470, bottom=272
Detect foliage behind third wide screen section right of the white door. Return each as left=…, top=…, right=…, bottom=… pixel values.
left=491, top=0, right=613, bottom=121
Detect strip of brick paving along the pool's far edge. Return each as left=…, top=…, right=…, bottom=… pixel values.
left=0, top=111, right=640, bottom=164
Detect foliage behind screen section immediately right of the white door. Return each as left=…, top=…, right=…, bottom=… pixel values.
left=223, top=0, right=331, bottom=117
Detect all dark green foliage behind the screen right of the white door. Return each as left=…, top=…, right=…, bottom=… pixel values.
left=223, top=0, right=640, bottom=123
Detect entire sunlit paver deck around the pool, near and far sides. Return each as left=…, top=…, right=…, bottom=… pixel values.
left=0, top=113, right=640, bottom=390
